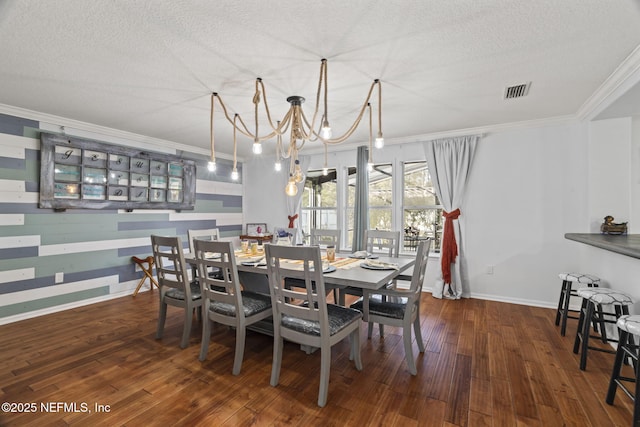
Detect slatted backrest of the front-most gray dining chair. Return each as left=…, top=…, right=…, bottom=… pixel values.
left=265, top=245, right=329, bottom=338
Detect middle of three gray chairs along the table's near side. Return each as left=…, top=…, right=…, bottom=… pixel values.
left=194, top=239, right=271, bottom=375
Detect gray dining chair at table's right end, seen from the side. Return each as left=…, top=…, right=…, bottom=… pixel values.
left=351, top=239, right=431, bottom=375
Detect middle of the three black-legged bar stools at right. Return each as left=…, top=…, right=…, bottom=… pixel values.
left=573, top=287, right=633, bottom=371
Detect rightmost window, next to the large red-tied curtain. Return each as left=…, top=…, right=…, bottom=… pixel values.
left=402, top=161, right=444, bottom=252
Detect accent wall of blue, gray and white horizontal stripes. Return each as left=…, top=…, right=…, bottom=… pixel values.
left=0, top=114, right=243, bottom=324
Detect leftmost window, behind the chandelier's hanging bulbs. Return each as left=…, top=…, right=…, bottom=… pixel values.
left=299, top=169, right=338, bottom=243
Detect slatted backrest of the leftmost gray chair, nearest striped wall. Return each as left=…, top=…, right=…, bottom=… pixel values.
left=151, top=236, right=191, bottom=300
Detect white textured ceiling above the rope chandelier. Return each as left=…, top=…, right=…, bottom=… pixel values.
left=0, top=0, right=640, bottom=156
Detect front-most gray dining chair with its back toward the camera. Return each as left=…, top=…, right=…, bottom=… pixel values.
left=266, top=245, right=362, bottom=407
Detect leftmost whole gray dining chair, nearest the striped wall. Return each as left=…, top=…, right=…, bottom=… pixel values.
left=151, top=236, right=202, bottom=348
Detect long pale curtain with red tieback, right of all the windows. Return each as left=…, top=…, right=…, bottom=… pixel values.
left=424, top=135, right=479, bottom=299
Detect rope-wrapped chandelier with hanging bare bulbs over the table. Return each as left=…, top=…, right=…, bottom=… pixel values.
left=208, top=59, right=384, bottom=196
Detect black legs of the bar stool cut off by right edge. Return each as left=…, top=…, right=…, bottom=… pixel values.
left=606, top=330, right=640, bottom=426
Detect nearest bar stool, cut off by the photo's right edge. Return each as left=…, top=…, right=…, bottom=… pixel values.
left=606, top=315, right=640, bottom=426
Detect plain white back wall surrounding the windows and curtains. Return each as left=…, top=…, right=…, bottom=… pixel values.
left=244, top=123, right=592, bottom=307
